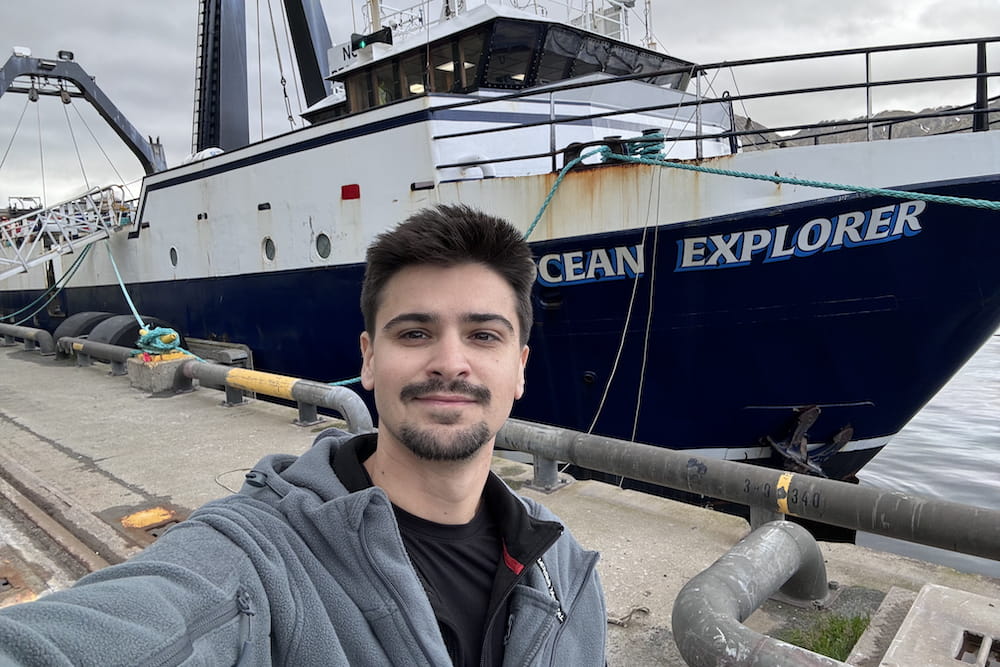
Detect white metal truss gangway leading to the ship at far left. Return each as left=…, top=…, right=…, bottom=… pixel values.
left=0, top=185, right=136, bottom=282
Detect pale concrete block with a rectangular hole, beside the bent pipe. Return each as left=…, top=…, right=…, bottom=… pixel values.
left=881, top=584, right=1000, bottom=667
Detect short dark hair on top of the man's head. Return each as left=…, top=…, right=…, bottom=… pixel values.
left=361, top=204, right=535, bottom=345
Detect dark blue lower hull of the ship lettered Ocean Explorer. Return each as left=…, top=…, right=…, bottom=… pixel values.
left=0, top=177, right=1000, bottom=478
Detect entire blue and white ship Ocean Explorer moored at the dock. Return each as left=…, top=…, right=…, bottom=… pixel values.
left=0, top=0, right=1000, bottom=490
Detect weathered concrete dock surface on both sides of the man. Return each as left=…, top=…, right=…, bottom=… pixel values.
left=0, top=347, right=1000, bottom=665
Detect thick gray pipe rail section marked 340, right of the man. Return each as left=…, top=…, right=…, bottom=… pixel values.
left=497, top=419, right=1000, bottom=560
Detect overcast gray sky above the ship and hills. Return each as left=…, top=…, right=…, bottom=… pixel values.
left=0, top=0, right=1000, bottom=207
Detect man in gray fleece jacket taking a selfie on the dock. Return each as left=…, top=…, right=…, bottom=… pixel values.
left=0, top=206, right=606, bottom=666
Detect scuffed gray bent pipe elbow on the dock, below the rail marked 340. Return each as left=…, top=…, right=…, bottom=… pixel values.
left=671, top=521, right=844, bottom=667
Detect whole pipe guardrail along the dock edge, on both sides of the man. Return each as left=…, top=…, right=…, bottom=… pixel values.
left=9, top=324, right=1000, bottom=560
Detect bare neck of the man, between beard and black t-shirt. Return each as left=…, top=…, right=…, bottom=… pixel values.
left=364, top=431, right=493, bottom=525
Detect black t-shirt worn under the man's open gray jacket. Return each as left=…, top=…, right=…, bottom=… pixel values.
left=333, top=437, right=506, bottom=666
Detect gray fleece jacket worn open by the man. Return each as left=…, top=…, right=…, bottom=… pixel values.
left=0, top=433, right=606, bottom=667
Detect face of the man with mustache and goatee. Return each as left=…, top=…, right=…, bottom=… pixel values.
left=361, top=263, right=528, bottom=461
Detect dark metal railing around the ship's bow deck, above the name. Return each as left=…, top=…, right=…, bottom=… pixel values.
left=434, top=36, right=1000, bottom=180
